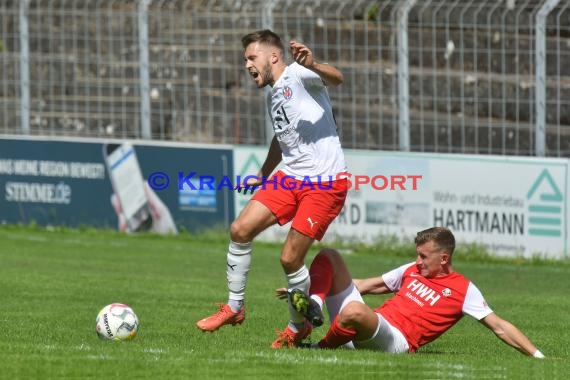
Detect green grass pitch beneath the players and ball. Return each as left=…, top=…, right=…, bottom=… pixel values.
left=0, top=226, right=570, bottom=380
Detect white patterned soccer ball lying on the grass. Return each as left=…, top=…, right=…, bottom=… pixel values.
left=96, top=303, right=139, bottom=340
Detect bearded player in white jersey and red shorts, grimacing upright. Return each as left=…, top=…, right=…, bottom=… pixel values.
left=196, top=30, right=348, bottom=348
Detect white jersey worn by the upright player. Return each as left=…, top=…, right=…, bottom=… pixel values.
left=267, top=62, right=347, bottom=182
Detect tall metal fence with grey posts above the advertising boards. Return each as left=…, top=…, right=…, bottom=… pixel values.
left=0, top=0, right=570, bottom=157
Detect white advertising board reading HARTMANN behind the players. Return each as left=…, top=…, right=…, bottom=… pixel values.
left=234, top=147, right=570, bottom=258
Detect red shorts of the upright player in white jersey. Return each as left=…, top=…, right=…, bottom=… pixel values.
left=251, top=170, right=348, bottom=240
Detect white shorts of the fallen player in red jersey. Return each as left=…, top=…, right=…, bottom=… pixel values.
left=325, top=284, right=409, bottom=354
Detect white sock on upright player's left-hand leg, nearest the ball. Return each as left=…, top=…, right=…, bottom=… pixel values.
left=226, top=241, right=252, bottom=312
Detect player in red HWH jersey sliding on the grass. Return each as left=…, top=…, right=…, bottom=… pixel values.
left=286, top=227, right=544, bottom=358
